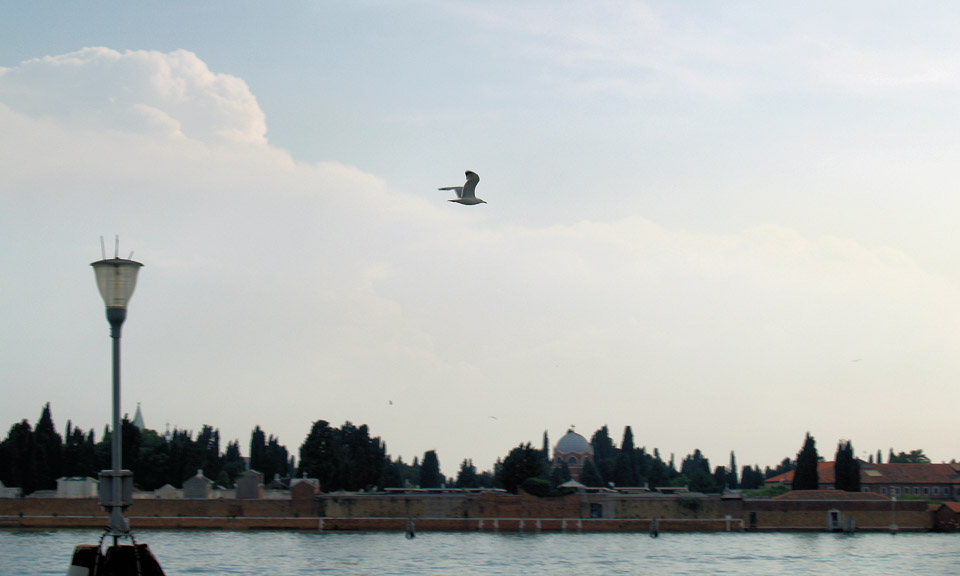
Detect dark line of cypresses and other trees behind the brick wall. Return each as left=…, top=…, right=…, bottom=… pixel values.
left=0, top=403, right=929, bottom=495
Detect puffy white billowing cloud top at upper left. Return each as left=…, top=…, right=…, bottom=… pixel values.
left=0, top=47, right=267, bottom=143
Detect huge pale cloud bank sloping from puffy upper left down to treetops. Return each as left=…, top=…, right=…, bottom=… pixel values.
left=0, top=49, right=960, bottom=474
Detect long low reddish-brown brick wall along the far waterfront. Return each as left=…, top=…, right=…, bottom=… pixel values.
left=0, top=492, right=935, bottom=532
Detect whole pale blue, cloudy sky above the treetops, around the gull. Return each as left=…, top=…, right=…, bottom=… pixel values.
left=0, top=0, right=960, bottom=476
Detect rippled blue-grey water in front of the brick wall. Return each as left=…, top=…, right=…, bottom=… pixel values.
left=0, top=530, right=960, bottom=576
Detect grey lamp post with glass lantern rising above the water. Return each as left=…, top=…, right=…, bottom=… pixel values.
left=90, top=257, right=143, bottom=546
